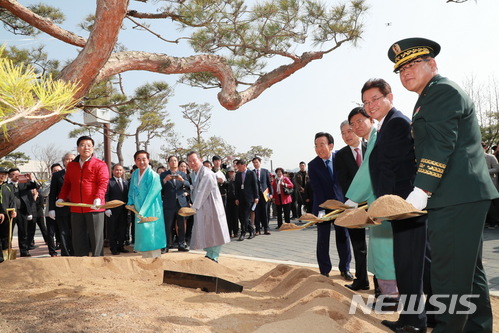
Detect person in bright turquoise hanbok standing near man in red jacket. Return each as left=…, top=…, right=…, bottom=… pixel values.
left=128, top=150, right=166, bottom=258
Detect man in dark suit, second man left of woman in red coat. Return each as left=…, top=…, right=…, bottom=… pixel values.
left=234, top=160, right=259, bottom=241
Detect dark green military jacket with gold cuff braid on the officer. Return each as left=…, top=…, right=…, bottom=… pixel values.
left=412, top=75, right=499, bottom=209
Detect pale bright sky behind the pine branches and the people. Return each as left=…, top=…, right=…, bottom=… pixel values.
left=0, top=0, right=499, bottom=169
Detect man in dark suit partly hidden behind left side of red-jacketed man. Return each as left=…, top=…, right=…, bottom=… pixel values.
left=48, top=153, right=76, bottom=256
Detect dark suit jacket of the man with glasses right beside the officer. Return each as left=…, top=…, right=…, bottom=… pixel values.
left=369, top=108, right=416, bottom=199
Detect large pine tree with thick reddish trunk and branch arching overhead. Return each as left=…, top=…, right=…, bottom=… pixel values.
left=0, top=0, right=367, bottom=156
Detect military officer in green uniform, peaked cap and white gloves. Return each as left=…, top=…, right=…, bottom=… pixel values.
left=392, top=38, right=499, bottom=333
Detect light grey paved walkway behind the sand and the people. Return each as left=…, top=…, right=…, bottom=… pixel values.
left=7, top=220, right=499, bottom=296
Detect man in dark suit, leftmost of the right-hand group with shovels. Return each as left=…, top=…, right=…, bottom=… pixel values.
left=308, top=132, right=353, bottom=281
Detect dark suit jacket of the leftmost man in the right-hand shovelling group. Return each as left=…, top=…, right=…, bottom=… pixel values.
left=308, top=153, right=345, bottom=215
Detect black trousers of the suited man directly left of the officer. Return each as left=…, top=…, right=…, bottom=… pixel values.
left=392, top=215, right=430, bottom=328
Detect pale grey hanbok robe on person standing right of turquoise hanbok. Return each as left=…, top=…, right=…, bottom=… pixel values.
left=190, top=166, right=230, bottom=250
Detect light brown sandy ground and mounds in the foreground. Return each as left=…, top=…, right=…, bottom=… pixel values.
left=0, top=252, right=497, bottom=333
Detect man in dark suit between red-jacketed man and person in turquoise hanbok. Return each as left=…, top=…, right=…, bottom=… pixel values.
left=104, top=164, right=130, bottom=255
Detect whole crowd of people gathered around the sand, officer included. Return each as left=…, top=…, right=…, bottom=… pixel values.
left=0, top=38, right=499, bottom=332
